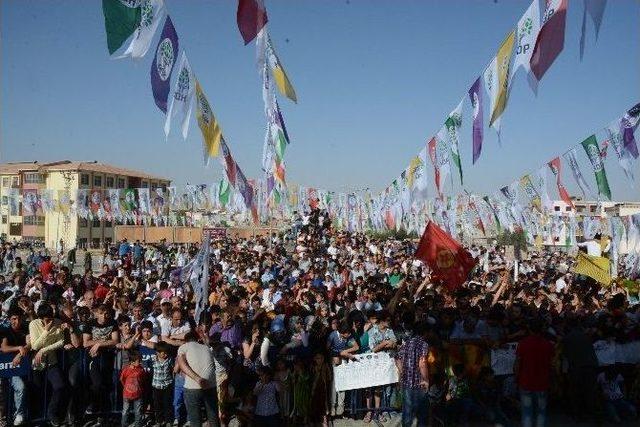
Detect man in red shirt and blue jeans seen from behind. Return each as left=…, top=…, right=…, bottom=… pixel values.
left=513, top=319, right=553, bottom=427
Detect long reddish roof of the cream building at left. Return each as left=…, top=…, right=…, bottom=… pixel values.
left=0, top=160, right=169, bottom=181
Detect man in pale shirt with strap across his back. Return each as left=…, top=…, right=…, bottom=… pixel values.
left=177, top=331, right=220, bottom=427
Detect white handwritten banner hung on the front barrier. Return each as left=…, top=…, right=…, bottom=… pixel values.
left=333, top=352, right=398, bottom=391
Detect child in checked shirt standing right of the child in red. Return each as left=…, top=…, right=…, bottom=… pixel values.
left=151, top=342, right=173, bottom=427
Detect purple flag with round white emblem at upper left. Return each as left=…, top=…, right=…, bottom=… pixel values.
left=151, top=16, right=178, bottom=114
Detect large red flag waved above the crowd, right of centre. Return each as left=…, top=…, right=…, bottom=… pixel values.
left=414, top=221, right=476, bottom=290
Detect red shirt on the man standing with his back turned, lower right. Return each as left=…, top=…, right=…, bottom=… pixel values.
left=516, top=335, right=553, bottom=391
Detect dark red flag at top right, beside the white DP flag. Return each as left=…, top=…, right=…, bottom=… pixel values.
left=530, top=0, right=567, bottom=80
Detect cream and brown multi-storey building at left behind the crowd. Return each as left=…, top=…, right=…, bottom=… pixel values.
left=0, top=160, right=171, bottom=248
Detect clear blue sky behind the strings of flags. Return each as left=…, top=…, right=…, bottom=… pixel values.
left=0, top=0, right=640, bottom=200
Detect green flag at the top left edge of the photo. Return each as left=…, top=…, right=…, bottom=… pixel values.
left=102, top=0, right=141, bottom=55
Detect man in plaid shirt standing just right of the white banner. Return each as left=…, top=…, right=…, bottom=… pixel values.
left=396, top=322, right=429, bottom=427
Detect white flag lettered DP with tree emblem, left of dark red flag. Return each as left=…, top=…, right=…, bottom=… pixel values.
left=509, top=0, right=540, bottom=92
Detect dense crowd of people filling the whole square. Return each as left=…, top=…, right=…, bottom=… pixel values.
left=0, top=210, right=640, bottom=427
